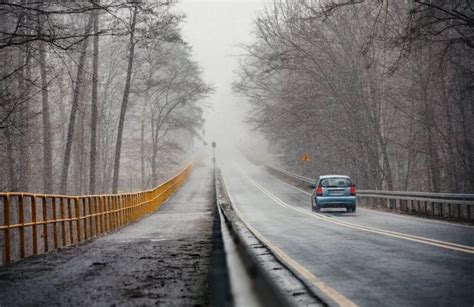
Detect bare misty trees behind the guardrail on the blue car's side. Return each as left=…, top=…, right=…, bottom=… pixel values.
left=234, top=0, right=474, bottom=193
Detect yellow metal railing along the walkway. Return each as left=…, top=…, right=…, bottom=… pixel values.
left=0, top=164, right=192, bottom=264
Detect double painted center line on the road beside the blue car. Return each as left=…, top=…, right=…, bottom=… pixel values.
left=247, top=177, right=474, bottom=254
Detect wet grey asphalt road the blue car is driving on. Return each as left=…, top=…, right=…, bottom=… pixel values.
left=218, top=152, right=474, bottom=306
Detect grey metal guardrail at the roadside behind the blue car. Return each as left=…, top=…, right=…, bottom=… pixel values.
left=265, top=165, right=474, bottom=220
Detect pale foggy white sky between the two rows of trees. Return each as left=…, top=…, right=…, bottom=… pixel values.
left=177, top=0, right=268, bottom=149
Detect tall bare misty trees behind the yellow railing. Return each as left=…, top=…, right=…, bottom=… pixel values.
left=0, top=0, right=212, bottom=194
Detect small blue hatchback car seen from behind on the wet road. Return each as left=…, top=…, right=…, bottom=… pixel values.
left=310, top=175, right=356, bottom=212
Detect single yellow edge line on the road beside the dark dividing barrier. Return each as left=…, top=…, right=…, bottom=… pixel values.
left=222, top=171, right=357, bottom=307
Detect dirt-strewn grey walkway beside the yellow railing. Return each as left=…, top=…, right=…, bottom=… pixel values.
left=0, top=167, right=213, bottom=306
